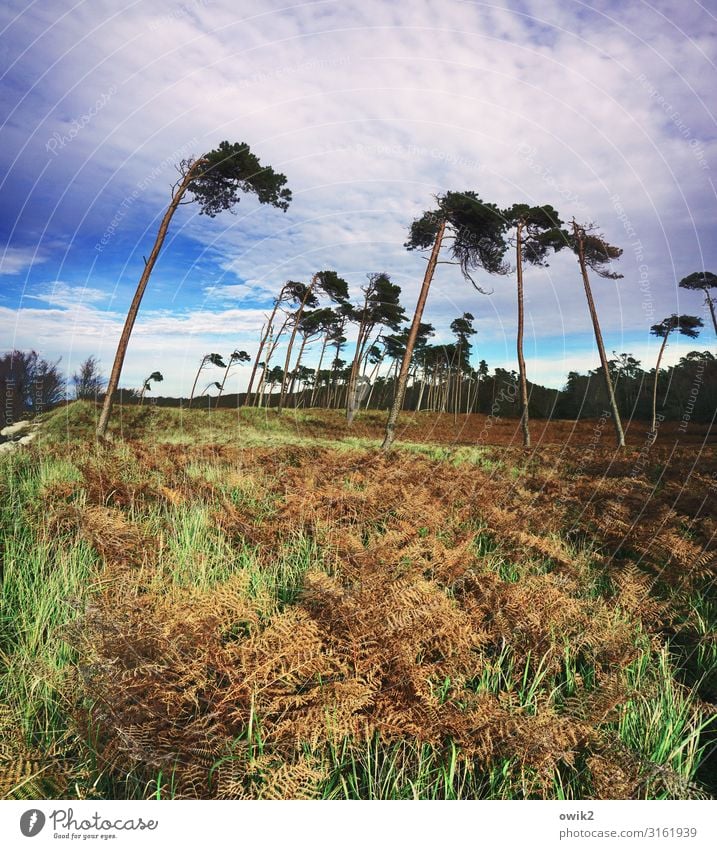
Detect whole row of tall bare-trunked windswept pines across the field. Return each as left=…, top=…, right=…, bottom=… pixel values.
left=7, top=141, right=717, bottom=450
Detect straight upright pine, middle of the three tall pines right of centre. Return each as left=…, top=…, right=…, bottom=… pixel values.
left=504, top=203, right=566, bottom=448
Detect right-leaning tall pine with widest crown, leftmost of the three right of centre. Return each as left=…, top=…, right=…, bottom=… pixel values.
left=381, top=191, right=507, bottom=451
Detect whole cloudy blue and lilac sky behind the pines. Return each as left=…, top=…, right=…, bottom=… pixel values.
left=0, top=0, right=717, bottom=395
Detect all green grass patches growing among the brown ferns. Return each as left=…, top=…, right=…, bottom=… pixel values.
left=0, top=404, right=717, bottom=799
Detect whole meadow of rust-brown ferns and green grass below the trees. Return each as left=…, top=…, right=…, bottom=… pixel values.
left=0, top=402, right=717, bottom=799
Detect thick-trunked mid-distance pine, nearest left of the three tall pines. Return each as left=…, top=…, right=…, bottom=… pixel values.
left=346, top=273, right=406, bottom=426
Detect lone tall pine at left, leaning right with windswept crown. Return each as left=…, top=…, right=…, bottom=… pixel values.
left=97, top=141, right=291, bottom=438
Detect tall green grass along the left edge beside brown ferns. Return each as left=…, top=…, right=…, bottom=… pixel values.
left=0, top=451, right=97, bottom=745
